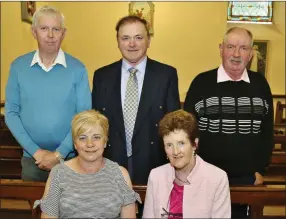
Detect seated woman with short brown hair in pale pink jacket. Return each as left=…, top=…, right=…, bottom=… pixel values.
left=143, top=110, right=231, bottom=218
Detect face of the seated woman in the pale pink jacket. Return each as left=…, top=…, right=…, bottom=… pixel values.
left=163, top=130, right=197, bottom=170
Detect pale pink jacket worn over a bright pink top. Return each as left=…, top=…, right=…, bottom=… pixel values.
left=143, top=155, right=231, bottom=218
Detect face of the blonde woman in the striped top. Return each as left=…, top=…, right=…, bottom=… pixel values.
left=74, top=125, right=106, bottom=162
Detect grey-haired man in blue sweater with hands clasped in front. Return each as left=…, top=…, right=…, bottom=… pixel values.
left=5, top=6, right=91, bottom=181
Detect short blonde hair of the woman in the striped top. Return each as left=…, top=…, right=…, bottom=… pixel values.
left=71, top=110, right=109, bottom=142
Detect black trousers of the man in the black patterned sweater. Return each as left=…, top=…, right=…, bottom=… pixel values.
left=228, top=174, right=255, bottom=219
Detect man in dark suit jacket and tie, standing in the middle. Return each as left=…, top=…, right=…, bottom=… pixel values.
left=92, top=16, right=180, bottom=184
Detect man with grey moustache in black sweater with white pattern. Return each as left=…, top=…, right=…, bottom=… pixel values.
left=184, top=27, right=274, bottom=218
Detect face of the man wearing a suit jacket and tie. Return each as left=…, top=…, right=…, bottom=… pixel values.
left=117, top=22, right=150, bottom=66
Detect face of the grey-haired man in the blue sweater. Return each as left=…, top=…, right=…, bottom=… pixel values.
left=32, top=15, right=66, bottom=53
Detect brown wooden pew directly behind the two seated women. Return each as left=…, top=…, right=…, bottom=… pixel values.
left=0, top=179, right=286, bottom=219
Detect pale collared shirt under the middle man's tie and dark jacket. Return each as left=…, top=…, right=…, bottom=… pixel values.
left=121, top=56, right=147, bottom=109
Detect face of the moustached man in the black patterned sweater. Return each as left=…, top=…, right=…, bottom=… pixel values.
left=220, top=30, right=252, bottom=80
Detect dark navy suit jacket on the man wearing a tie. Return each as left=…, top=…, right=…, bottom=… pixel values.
left=92, top=58, right=180, bottom=184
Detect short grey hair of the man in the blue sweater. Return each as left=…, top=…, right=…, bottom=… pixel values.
left=32, top=5, right=65, bottom=28
